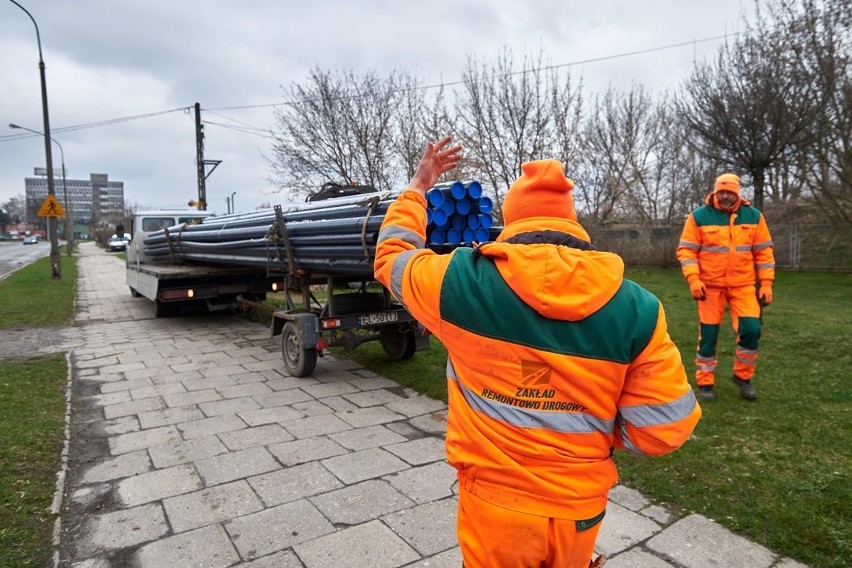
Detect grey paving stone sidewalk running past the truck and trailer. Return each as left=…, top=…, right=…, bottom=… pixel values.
left=54, top=243, right=807, bottom=568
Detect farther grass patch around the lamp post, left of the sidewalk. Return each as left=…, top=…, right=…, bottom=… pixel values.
left=0, top=255, right=77, bottom=329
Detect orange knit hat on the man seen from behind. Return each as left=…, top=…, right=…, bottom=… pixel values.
left=503, top=160, right=577, bottom=225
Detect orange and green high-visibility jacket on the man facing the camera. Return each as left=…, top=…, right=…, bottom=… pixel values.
left=677, top=193, right=775, bottom=288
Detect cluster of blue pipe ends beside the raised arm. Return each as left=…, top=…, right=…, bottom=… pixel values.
left=426, top=180, right=494, bottom=247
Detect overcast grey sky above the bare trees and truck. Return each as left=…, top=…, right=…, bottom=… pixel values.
left=0, top=0, right=752, bottom=217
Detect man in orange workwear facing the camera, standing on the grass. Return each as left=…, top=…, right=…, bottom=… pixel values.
left=677, top=173, right=775, bottom=400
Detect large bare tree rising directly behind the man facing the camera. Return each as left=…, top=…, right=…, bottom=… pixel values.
left=677, top=5, right=824, bottom=208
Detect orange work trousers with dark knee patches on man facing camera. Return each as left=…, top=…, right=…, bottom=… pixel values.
left=695, top=286, right=760, bottom=386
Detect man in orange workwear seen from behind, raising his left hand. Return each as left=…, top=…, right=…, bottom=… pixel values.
left=375, top=137, right=701, bottom=568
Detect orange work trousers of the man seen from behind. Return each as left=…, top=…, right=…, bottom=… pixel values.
left=458, top=486, right=604, bottom=568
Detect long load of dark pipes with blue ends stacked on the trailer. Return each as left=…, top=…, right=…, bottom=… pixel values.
left=142, top=181, right=499, bottom=280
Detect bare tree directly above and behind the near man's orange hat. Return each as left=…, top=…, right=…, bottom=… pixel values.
left=456, top=48, right=581, bottom=222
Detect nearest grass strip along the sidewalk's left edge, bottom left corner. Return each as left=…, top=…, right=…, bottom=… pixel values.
left=0, top=352, right=66, bottom=568
